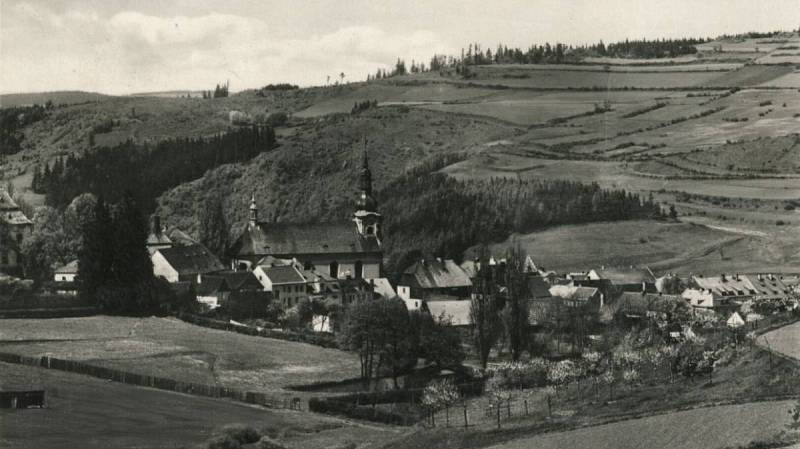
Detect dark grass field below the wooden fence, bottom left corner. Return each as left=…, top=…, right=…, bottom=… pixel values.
left=0, top=363, right=397, bottom=449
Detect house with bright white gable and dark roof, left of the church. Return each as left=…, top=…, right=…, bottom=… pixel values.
left=150, top=243, right=225, bottom=282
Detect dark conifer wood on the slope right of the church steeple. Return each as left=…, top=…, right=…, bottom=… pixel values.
left=379, top=171, right=661, bottom=270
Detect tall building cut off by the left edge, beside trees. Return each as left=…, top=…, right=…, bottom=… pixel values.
left=0, top=189, right=33, bottom=274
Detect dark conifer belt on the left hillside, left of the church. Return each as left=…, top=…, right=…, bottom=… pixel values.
left=31, top=126, right=275, bottom=213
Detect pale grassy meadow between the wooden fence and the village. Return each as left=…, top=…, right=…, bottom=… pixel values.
left=0, top=316, right=359, bottom=392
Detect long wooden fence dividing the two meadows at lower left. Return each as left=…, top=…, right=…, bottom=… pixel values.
left=0, top=352, right=302, bottom=410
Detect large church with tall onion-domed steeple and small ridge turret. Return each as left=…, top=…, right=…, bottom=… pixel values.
left=229, top=151, right=383, bottom=280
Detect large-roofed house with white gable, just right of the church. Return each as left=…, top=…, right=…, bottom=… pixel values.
left=398, top=259, right=472, bottom=299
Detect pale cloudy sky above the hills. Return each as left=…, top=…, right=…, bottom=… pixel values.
left=0, top=0, right=800, bottom=94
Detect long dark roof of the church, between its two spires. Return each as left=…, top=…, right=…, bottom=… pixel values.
left=231, top=222, right=381, bottom=256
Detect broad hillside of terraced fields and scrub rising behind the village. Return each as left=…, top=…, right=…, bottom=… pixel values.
left=0, top=34, right=800, bottom=274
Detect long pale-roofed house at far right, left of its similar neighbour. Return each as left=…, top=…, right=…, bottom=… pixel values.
left=681, top=274, right=758, bottom=309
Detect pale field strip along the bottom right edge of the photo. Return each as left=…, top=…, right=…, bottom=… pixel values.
left=491, top=401, right=794, bottom=449
